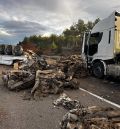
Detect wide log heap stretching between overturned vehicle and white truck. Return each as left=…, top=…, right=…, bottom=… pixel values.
left=3, top=54, right=88, bottom=95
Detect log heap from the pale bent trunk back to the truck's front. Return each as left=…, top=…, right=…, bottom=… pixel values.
left=31, top=55, right=88, bottom=98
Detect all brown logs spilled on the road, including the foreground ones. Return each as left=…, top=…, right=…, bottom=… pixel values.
left=2, top=52, right=120, bottom=129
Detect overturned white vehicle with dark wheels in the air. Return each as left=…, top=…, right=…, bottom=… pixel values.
left=0, top=44, right=26, bottom=65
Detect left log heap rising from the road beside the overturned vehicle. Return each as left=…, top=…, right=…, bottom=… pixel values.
left=2, top=52, right=47, bottom=91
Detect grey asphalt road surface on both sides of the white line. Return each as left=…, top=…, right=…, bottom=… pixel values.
left=0, top=73, right=120, bottom=129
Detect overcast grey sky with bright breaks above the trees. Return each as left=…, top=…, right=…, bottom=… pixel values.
left=0, top=0, right=120, bottom=43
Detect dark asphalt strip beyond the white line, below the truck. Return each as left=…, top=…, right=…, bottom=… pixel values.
left=79, top=77, right=120, bottom=105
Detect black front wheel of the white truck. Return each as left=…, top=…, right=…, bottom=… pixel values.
left=92, top=62, right=104, bottom=78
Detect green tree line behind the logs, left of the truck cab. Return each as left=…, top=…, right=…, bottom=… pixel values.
left=19, top=18, right=100, bottom=53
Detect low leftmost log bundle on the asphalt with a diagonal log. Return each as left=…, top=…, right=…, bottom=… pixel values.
left=3, top=70, right=35, bottom=91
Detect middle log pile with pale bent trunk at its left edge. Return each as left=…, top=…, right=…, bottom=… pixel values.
left=31, top=70, right=79, bottom=95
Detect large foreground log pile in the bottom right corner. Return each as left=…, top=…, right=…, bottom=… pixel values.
left=61, top=106, right=120, bottom=129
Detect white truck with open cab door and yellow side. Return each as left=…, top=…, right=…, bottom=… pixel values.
left=82, top=11, right=120, bottom=78
